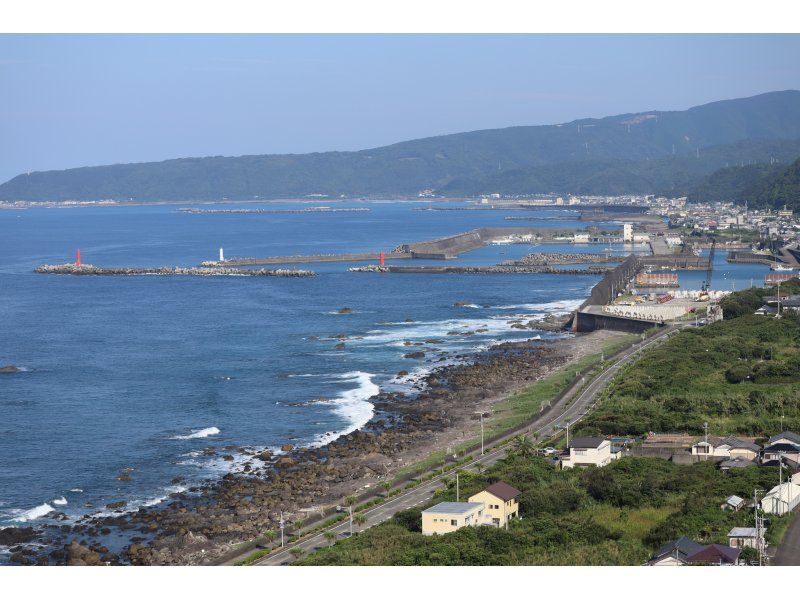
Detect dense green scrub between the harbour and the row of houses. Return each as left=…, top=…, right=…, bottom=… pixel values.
left=576, top=312, right=800, bottom=436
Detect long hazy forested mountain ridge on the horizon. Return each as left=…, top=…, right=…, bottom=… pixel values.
left=0, top=91, right=800, bottom=201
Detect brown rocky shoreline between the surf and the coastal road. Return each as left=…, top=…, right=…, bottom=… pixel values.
left=0, top=318, right=620, bottom=565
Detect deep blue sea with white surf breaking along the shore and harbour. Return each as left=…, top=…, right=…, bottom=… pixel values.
left=0, top=202, right=766, bottom=540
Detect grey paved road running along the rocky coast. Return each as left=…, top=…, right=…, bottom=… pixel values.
left=245, top=324, right=688, bottom=565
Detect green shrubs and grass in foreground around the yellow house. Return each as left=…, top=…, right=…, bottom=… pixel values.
left=299, top=454, right=782, bottom=565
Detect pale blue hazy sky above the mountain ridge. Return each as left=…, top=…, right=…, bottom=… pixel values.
left=0, top=35, right=800, bottom=181
